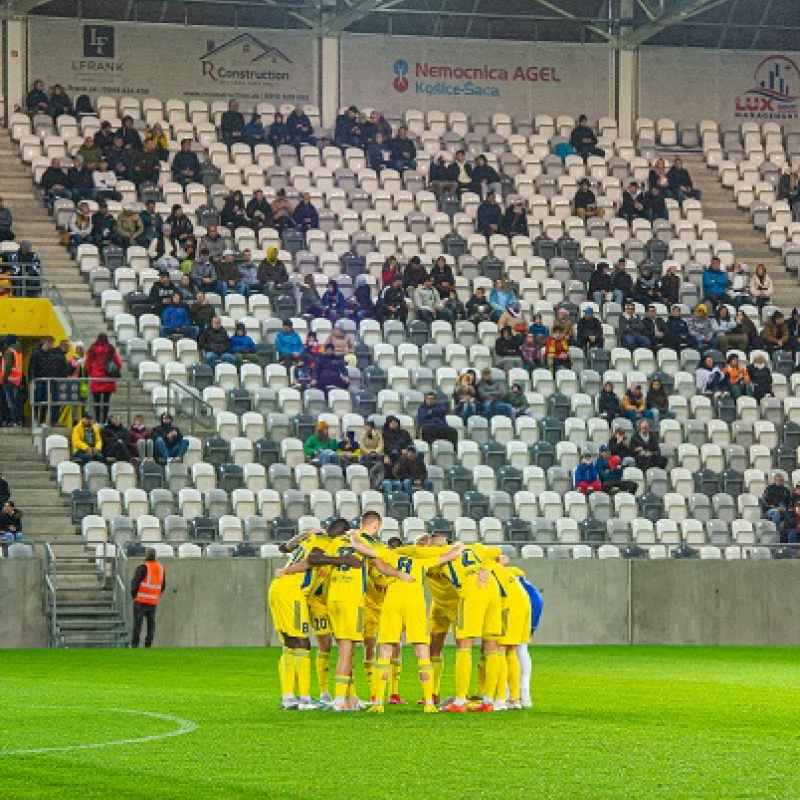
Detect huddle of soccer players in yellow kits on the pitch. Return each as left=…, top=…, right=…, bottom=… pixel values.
left=269, top=511, right=541, bottom=713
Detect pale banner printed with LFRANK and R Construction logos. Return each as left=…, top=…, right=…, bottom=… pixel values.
left=28, top=17, right=317, bottom=107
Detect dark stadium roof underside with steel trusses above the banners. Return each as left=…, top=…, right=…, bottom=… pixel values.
left=5, top=0, right=800, bottom=50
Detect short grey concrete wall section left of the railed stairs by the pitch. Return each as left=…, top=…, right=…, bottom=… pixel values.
left=0, top=558, right=47, bottom=648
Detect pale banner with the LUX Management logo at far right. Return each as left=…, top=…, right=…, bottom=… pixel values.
left=639, top=47, right=800, bottom=122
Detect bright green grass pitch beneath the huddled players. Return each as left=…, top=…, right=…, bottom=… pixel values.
left=0, top=647, right=800, bottom=800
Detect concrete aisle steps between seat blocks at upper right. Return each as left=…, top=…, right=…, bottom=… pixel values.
left=681, top=152, right=800, bottom=312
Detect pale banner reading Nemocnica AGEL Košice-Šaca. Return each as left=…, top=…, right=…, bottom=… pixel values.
left=341, top=35, right=613, bottom=119
